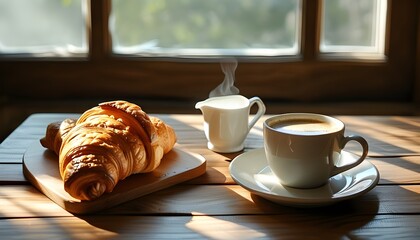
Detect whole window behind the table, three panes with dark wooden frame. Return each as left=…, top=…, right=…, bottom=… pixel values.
left=0, top=0, right=420, bottom=112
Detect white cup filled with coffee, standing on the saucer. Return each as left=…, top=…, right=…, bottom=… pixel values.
left=263, top=113, right=368, bottom=188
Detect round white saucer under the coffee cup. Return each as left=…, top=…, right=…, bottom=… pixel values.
left=229, top=149, right=379, bottom=207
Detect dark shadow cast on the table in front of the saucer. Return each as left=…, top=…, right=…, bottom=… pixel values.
left=246, top=194, right=379, bottom=239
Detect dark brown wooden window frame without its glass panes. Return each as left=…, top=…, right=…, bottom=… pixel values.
left=0, top=0, right=420, bottom=112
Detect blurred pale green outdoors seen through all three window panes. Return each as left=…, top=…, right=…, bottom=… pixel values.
left=0, top=0, right=387, bottom=58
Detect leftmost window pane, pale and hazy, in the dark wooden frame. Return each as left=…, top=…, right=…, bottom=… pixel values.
left=0, top=0, right=87, bottom=55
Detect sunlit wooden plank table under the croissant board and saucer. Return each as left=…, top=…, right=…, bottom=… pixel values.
left=0, top=114, right=420, bottom=239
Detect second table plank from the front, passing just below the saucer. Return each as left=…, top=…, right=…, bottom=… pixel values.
left=0, top=185, right=420, bottom=218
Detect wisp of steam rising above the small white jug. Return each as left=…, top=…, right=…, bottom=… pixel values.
left=209, top=60, right=239, bottom=97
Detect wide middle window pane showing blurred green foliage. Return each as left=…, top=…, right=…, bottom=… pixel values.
left=110, top=0, right=300, bottom=56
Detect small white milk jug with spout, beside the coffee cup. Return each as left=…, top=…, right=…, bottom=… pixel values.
left=195, top=95, right=265, bottom=153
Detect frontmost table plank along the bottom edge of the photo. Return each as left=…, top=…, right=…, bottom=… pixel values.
left=0, top=213, right=420, bottom=239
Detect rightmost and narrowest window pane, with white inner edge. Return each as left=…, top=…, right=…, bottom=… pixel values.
left=320, top=0, right=386, bottom=53
